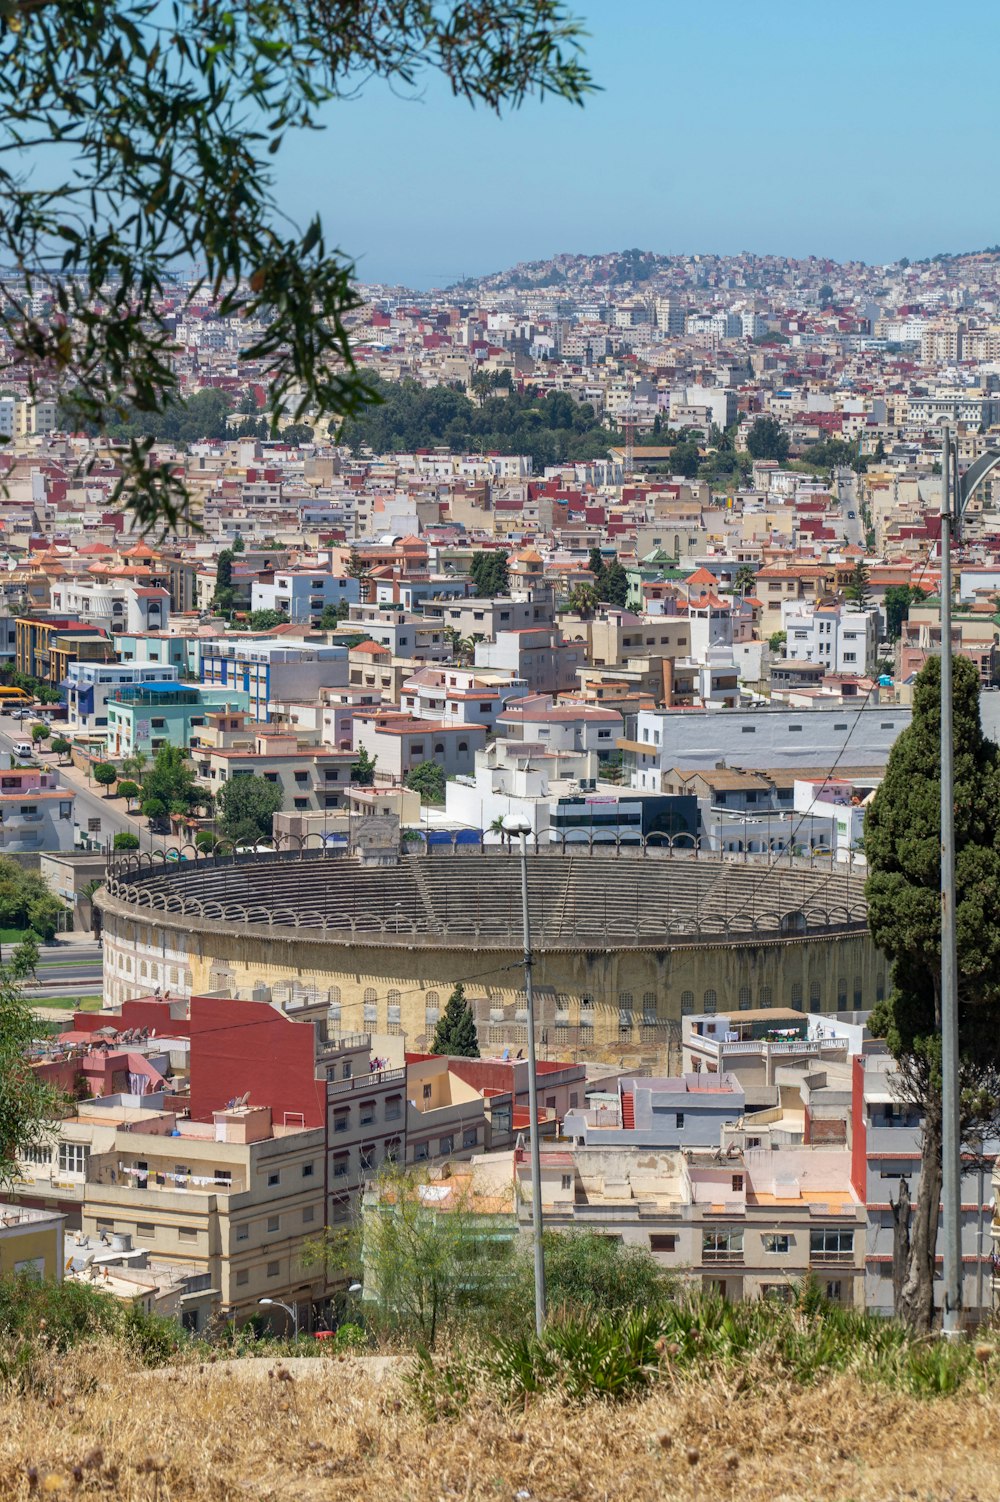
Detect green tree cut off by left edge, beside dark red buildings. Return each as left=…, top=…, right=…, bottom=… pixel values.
left=0, top=945, right=65, bottom=1190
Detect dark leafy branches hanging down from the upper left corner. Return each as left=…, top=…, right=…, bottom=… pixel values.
left=0, top=0, right=590, bottom=526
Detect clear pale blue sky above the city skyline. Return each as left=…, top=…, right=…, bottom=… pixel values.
left=276, top=0, right=1000, bottom=288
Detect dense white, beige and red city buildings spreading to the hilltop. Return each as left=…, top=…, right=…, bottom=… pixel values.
left=0, top=252, right=1000, bottom=1329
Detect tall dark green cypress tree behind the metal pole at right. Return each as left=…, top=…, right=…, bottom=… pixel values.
left=865, top=658, right=1000, bottom=1329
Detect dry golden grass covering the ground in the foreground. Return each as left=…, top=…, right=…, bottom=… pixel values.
left=0, top=1346, right=1000, bottom=1502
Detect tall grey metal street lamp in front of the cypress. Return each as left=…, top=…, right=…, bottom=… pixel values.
left=941, top=428, right=1000, bottom=1335
